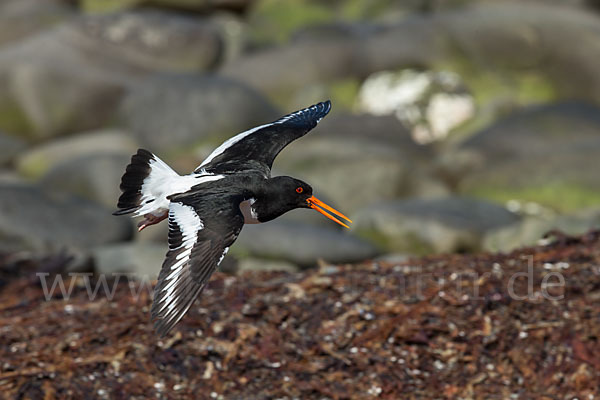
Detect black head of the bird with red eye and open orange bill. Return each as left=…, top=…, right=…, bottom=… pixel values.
left=257, top=176, right=352, bottom=228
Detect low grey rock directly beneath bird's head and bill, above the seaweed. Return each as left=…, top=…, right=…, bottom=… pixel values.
left=231, top=220, right=378, bottom=266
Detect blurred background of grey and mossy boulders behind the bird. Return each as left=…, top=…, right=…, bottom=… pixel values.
left=0, top=0, right=600, bottom=276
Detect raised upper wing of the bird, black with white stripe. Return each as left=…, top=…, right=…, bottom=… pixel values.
left=195, top=100, right=331, bottom=176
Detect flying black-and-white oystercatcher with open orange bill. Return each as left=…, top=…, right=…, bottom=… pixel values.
left=114, top=101, right=352, bottom=336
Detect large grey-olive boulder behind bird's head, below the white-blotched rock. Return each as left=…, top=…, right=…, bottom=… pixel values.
left=275, top=114, right=447, bottom=212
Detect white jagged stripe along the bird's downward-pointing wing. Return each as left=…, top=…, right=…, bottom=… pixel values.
left=159, top=203, right=204, bottom=319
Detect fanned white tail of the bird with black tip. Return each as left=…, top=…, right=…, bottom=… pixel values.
left=113, top=149, right=179, bottom=215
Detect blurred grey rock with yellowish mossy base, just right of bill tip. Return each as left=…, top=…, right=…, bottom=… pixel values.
left=352, top=197, right=519, bottom=254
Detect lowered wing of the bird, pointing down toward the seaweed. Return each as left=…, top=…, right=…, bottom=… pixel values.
left=151, top=195, right=244, bottom=337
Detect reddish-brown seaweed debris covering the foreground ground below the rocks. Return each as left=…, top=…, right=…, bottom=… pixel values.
left=0, top=233, right=600, bottom=399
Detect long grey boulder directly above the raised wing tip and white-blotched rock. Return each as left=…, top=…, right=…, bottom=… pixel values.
left=221, top=9, right=444, bottom=97
